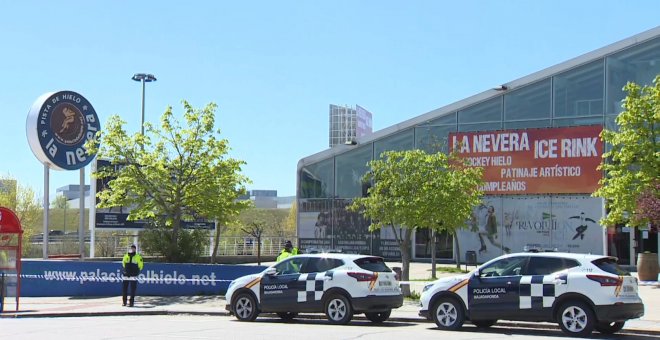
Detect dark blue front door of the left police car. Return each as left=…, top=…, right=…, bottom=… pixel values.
left=260, top=257, right=308, bottom=312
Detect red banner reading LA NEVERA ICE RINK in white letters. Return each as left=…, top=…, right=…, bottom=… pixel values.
left=449, top=126, right=603, bottom=195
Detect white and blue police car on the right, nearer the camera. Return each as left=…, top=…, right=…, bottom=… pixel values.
left=419, top=252, right=644, bottom=337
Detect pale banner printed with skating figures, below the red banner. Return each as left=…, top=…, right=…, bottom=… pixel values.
left=458, top=196, right=604, bottom=262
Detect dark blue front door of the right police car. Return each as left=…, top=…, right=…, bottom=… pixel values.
left=468, top=256, right=528, bottom=320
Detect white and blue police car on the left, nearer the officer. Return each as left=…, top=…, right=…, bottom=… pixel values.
left=225, top=254, right=403, bottom=324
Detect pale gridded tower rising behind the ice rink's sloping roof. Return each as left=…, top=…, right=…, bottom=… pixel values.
left=329, top=104, right=372, bottom=148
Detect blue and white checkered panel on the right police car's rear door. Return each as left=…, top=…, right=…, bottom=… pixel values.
left=519, top=275, right=555, bottom=309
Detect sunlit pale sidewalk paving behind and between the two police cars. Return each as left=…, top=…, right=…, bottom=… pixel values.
left=0, top=263, right=660, bottom=336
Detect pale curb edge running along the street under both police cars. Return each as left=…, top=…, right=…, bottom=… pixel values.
left=0, top=310, right=660, bottom=336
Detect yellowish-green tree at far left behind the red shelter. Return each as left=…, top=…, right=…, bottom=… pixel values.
left=0, top=176, right=43, bottom=256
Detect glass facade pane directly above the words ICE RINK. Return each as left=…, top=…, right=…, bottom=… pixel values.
left=553, top=59, right=605, bottom=117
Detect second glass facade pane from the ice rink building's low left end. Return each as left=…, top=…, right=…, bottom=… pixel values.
left=335, top=143, right=372, bottom=198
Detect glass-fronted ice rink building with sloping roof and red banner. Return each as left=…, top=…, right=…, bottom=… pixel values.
left=297, top=27, right=660, bottom=264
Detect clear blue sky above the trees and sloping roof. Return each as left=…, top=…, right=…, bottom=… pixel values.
left=0, top=0, right=660, bottom=196
